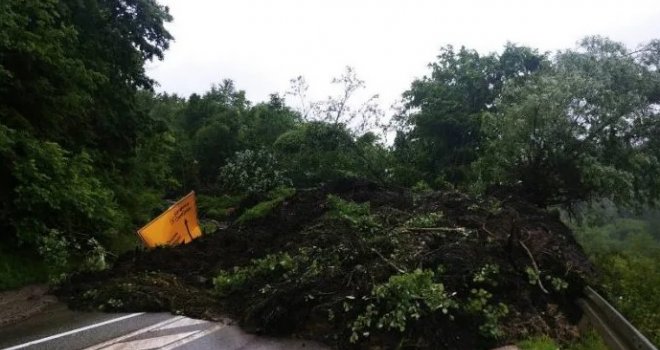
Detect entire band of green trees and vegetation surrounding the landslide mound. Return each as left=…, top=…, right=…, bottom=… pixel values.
left=0, top=0, right=660, bottom=342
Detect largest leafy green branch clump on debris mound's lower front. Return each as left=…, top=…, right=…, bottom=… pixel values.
left=351, top=269, right=457, bottom=342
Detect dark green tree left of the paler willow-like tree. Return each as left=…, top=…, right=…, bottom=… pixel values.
left=395, top=44, right=546, bottom=184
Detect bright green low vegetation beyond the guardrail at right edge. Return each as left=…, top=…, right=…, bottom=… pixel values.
left=574, top=209, right=660, bottom=343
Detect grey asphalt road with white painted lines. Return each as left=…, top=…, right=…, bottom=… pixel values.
left=0, top=303, right=326, bottom=350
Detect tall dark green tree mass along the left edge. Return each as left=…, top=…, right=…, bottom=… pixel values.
left=0, top=0, right=171, bottom=274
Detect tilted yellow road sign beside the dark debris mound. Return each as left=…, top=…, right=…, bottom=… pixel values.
left=138, top=192, right=202, bottom=248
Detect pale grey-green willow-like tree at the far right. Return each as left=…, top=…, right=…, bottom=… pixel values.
left=476, top=37, right=660, bottom=206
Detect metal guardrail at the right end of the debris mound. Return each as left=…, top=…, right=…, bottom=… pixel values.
left=577, top=287, right=658, bottom=350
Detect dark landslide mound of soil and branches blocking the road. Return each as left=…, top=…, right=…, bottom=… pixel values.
left=57, top=180, right=592, bottom=349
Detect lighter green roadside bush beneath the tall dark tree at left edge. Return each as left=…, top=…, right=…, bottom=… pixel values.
left=0, top=126, right=126, bottom=273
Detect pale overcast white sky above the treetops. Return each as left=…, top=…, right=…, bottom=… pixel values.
left=148, top=0, right=660, bottom=107
